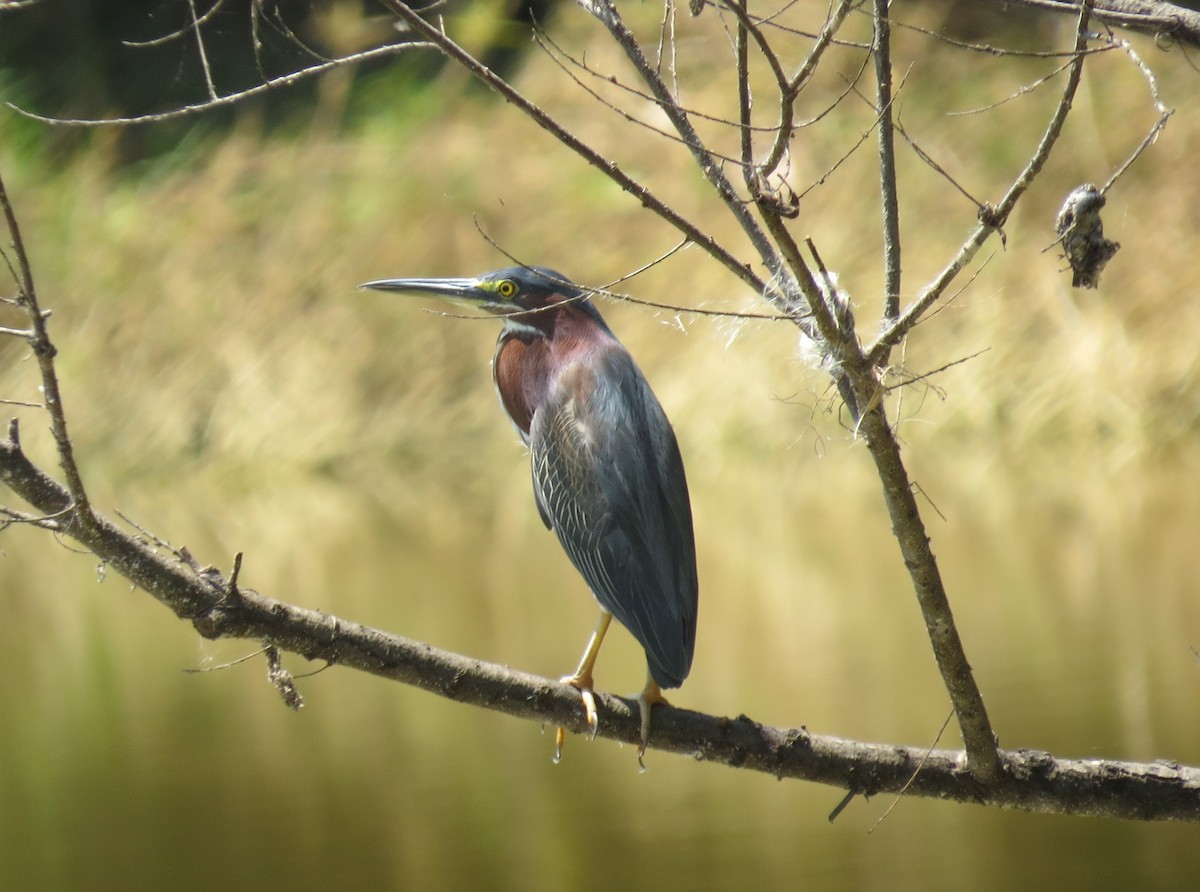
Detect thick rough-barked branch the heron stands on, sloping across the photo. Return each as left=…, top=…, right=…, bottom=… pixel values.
left=0, top=432, right=1200, bottom=822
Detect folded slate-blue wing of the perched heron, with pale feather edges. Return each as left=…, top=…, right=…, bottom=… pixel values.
left=530, top=346, right=697, bottom=687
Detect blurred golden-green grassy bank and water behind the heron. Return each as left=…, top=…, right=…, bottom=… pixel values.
left=0, top=5, right=1200, bottom=890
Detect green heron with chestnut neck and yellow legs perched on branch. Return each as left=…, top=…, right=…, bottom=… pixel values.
left=361, top=267, right=697, bottom=756
